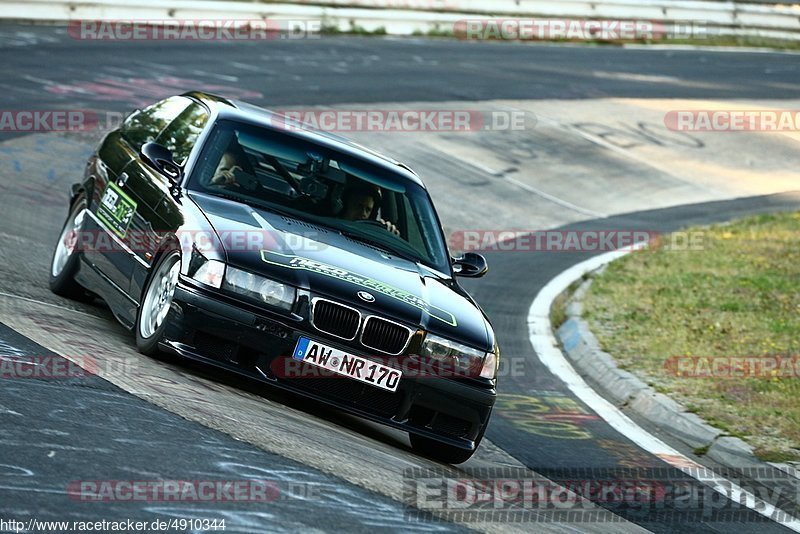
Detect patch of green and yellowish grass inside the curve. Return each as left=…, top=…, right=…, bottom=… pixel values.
left=584, top=212, right=800, bottom=461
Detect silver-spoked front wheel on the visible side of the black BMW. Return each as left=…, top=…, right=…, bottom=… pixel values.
left=134, top=250, right=181, bottom=356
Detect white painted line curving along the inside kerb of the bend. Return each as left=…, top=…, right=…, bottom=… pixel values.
left=528, top=242, right=800, bottom=532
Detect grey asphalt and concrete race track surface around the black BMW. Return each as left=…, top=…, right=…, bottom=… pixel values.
left=0, top=25, right=800, bottom=533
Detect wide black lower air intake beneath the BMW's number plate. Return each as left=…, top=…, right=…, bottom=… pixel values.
left=293, top=376, right=403, bottom=417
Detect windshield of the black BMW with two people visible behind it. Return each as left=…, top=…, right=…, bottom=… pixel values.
left=189, top=121, right=449, bottom=273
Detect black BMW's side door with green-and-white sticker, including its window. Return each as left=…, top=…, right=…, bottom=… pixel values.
left=85, top=97, right=192, bottom=293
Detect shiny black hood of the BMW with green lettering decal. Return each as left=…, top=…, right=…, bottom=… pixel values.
left=190, top=193, right=494, bottom=350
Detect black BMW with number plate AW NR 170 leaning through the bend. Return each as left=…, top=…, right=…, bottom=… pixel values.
left=50, top=92, right=499, bottom=463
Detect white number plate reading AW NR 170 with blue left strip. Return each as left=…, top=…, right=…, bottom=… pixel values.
left=292, top=337, right=403, bottom=391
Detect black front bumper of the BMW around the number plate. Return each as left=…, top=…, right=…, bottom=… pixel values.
left=161, top=283, right=496, bottom=450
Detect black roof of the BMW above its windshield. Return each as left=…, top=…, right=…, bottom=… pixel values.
left=182, top=91, right=425, bottom=188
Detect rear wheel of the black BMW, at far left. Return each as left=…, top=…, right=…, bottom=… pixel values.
left=49, top=193, right=94, bottom=302
